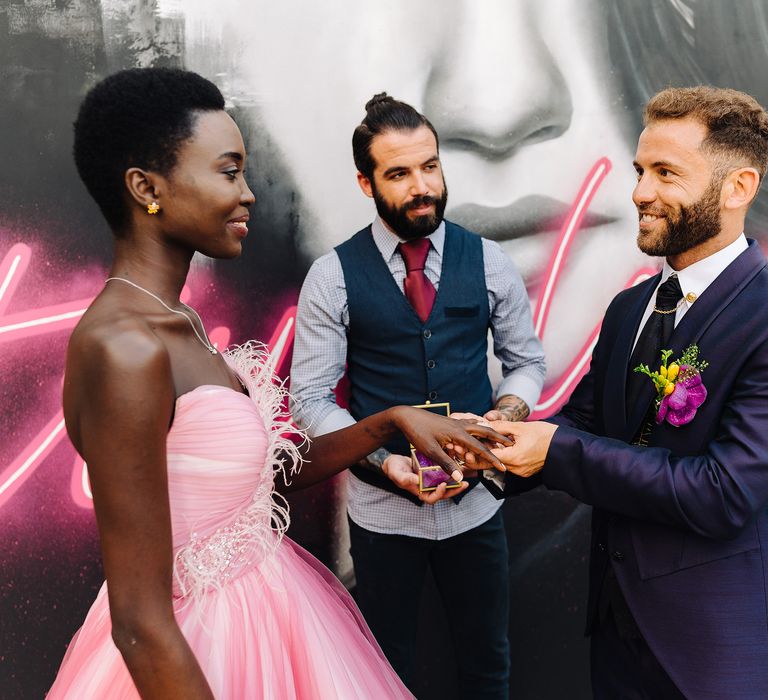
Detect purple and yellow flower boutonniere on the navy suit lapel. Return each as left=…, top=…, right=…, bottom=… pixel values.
left=634, top=345, right=708, bottom=428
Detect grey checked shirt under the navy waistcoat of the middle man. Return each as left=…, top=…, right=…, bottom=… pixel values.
left=291, top=218, right=545, bottom=540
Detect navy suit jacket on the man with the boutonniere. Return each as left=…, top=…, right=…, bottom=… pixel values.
left=541, top=241, right=768, bottom=700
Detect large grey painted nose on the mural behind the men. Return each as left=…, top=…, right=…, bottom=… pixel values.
left=424, top=1, right=573, bottom=158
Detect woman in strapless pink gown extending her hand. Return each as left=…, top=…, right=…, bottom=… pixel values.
left=47, top=69, right=509, bottom=700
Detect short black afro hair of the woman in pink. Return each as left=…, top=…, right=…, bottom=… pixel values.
left=74, top=68, right=224, bottom=236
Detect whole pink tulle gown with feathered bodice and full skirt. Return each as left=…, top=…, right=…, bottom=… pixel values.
left=47, top=345, right=412, bottom=700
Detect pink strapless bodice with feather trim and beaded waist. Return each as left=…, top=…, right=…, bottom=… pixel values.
left=167, top=346, right=299, bottom=596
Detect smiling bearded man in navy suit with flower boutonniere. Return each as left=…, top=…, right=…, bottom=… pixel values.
left=488, top=87, right=768, bottom=700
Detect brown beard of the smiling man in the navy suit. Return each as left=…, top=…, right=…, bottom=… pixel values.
left=637, top=177, right=723, bottom=257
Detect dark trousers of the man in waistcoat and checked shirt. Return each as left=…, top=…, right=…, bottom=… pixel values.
left=349, top=511, right=509, bottom=700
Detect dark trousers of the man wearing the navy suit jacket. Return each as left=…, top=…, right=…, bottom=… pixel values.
left=591, top=611, right=685, bottom=700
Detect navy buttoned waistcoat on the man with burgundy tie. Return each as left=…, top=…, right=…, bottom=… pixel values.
left=336, top=221, right=493, bottom=495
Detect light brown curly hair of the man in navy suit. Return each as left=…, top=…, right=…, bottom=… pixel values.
left=643, top=85, right=768, bottom=182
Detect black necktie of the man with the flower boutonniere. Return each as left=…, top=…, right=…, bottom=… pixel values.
left=627, top=274, right=683, bottom=422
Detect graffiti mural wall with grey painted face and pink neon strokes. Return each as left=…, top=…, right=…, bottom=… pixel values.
left=0, top=0, right=768, bottom=699
